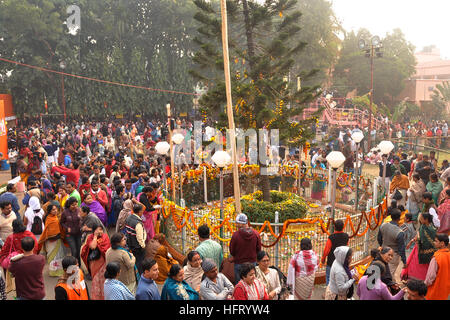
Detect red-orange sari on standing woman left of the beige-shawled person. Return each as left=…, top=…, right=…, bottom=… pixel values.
left=81, top=233, right=111, bottom=300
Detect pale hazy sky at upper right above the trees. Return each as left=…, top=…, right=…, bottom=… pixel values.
left=331, top=0, right=450, bottom=59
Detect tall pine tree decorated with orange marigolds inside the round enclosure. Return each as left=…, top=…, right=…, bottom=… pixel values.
left=191, top=0, right=322, bottom=201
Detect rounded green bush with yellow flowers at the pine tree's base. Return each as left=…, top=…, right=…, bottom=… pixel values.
left=241, top=190, right=309, bottom=223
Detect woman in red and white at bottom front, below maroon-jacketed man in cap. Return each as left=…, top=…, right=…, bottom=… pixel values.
left=233, top=263, right=270, bottom=300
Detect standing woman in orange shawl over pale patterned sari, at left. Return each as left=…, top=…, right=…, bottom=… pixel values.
left=38, top=204, right=65, bottom=277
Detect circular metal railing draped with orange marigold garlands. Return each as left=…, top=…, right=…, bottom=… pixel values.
left=161, top=165, right=387, bottom=283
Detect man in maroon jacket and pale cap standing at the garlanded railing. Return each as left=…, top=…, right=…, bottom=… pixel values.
left=230, top=213, right=261, bottom=284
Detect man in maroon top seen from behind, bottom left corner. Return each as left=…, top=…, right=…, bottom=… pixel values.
left=9, top=237, right=45, bottom=300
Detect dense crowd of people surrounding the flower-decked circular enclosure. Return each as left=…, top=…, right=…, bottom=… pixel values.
left=0, top=120, right=450, bottom=300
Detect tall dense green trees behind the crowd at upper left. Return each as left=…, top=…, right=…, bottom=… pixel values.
left=0, top=0, right=195, bottom=116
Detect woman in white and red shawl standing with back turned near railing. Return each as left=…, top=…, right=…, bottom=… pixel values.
left=287, top=238, right=319, bottom=300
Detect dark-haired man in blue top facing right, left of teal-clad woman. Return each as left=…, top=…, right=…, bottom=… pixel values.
left=136, top=258, right=161, bottom=300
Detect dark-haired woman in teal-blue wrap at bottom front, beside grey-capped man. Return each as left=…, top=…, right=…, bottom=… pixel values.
left=161, top=264, right=199, bottom=300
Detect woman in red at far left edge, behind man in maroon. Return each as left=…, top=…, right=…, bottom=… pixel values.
left=0, top=219, right=38, bottom=294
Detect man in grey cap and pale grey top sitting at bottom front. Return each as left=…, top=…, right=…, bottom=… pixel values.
left=200, top=258, right=234, bottom=300
